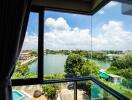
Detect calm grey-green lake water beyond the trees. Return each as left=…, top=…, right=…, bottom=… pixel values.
left=29, top=54, right=110, bottom=75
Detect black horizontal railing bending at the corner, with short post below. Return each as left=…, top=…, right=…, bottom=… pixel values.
left=12, top=77, right=129, bottom=100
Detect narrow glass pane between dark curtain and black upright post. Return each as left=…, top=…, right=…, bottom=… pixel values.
left=12, top=13, right=38, bottom=79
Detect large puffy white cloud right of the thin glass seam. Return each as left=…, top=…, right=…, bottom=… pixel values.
left=93, top=21, right=132, bottom=50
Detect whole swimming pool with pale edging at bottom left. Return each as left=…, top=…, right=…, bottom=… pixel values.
left=12, top=90, right=30, bottom=100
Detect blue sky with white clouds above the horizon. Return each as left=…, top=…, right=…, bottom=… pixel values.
left=23, top=1, right=132, bottom=50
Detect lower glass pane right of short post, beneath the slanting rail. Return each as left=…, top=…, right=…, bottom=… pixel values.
left=77, top=81, right=117, bottom=100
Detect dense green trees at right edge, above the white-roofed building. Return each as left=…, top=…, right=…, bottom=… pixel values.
left=106, top=54, right=132, bottom=79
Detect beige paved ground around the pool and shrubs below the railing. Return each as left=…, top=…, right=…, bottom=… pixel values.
left=13, top=85, right=90, bottom=100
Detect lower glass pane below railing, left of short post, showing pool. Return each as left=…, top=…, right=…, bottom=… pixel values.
left=12, top=83, right=74, bottom=100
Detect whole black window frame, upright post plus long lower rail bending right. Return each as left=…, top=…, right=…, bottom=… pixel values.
left=11, top=7, right=129, bottom=100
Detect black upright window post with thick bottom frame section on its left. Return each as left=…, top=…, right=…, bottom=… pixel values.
left=11, top=9, right=44, bottom=86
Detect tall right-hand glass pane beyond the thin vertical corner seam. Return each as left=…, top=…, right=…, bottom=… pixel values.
left=92, top=1, right=132, bottom=98
